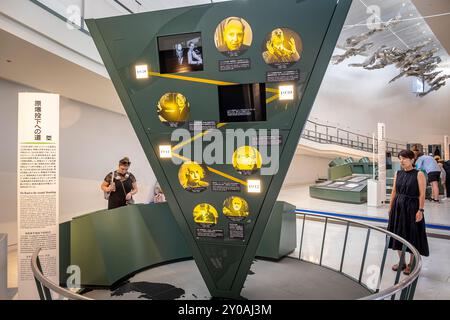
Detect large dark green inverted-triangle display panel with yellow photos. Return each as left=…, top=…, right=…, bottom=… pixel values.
left=87, top=0, right=351, bottom=298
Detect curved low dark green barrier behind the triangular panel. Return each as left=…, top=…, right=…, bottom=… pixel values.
left=60, top=202, right=297, bottom=288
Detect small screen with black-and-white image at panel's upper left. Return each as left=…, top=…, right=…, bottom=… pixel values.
left=158, top=32, right=203, bottom=73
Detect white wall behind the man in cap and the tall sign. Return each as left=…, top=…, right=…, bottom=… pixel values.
left=0, top=79, right=156, bottom=244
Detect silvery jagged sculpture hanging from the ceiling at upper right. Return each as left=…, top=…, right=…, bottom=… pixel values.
left=331, top=16, right=450, bottom=97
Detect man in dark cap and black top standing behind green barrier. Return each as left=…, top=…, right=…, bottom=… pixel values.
left=101, top=157, right=138, bottom=210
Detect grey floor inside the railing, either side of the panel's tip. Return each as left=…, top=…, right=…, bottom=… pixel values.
left=84, top=257, right=371, bottom=300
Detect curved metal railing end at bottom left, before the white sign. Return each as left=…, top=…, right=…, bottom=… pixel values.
left=31, top=249, right=92, bottom=300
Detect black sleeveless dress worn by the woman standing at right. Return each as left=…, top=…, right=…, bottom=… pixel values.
left=388, top=169, right=430, bottom=257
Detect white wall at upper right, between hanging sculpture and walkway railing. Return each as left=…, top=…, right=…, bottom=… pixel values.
left=311, top=51, right=450, bottom=145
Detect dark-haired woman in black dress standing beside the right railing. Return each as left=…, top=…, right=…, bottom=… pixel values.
left=388, top=150, right=430, bottom=274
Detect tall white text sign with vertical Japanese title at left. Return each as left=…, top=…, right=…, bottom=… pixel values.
left=17, top=93, right=59, bottom=300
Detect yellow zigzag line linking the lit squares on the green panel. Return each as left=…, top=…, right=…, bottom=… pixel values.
left=148, top=71, right=280, bottom=186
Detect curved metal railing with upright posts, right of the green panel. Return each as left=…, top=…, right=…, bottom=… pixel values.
left=296, top=212, right=422, bottom=300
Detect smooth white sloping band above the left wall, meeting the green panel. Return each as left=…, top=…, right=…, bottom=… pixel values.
left=0, top=29, right=124, bottom=113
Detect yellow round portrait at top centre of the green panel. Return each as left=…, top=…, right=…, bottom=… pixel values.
left=214, top=17, right=253, bottom=57
